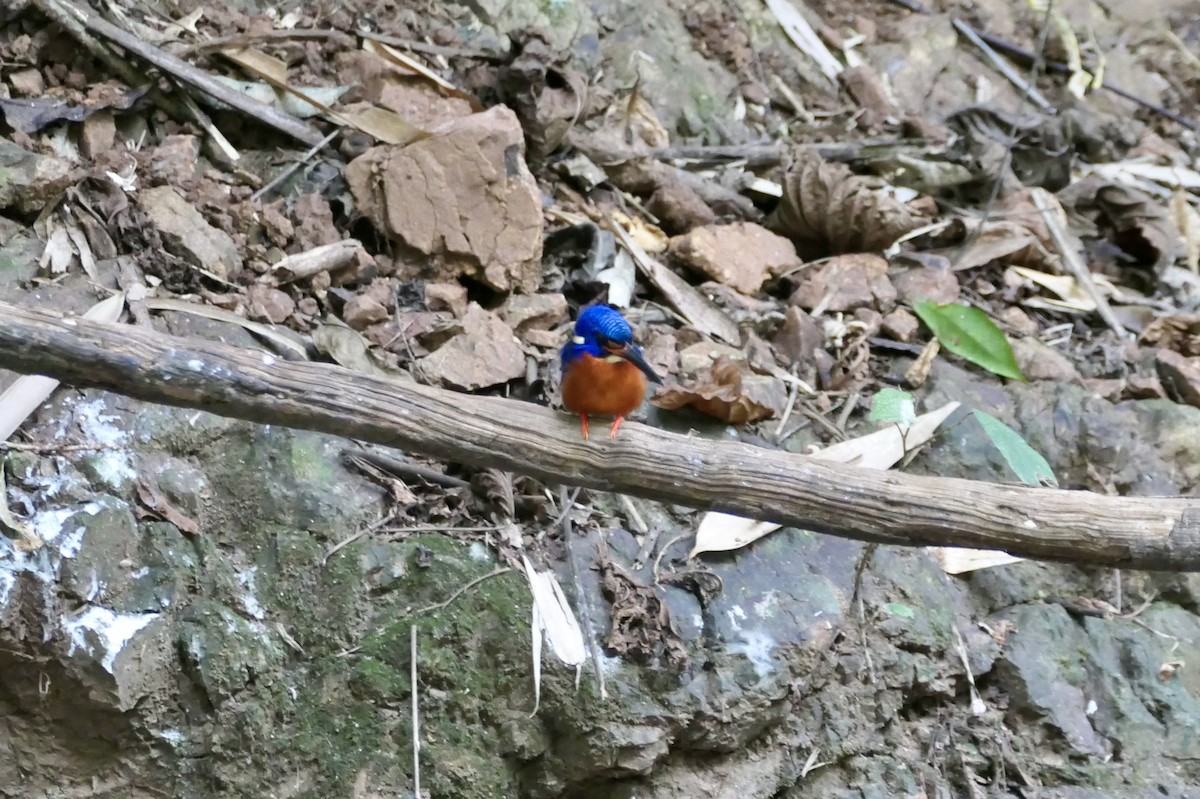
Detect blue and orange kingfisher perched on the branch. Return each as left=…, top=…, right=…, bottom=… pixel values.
left=563, top=305, right=662, bottom=440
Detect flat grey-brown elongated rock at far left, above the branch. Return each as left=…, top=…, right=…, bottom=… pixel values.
left=138, top=186, right=241, bottom=281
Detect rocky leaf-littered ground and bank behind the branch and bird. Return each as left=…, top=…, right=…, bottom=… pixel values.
left=0, top=0, right=1200, bottom=799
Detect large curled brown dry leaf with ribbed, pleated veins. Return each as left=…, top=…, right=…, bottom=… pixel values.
left=767, top=149, right=929, bottom=258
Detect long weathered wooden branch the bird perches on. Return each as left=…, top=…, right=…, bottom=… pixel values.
left=0, top=297, right=1200, bottom=571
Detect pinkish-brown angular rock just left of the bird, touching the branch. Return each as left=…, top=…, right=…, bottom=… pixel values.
left=420, top=302, right=526, bottom=391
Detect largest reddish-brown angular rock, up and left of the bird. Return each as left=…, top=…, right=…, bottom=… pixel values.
left=346, top=106, right=542, bottom=293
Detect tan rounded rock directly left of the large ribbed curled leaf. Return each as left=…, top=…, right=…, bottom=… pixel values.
left=671, top=222, right=800, bottom=294
